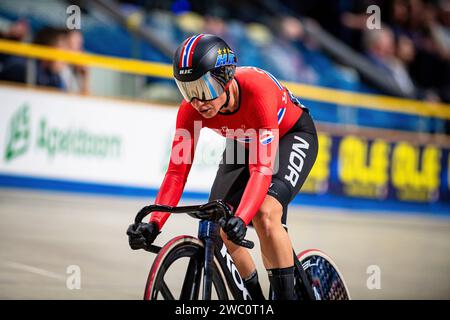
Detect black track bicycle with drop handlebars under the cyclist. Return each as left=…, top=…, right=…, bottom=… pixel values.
left=135, top=200, right=350, bottom=300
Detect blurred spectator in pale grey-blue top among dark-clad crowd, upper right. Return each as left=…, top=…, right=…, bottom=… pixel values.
left=364, top=26, right=415, bottom=96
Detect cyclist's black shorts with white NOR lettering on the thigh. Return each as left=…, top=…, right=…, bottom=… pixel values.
left=209, top=112, right=318, bottom=224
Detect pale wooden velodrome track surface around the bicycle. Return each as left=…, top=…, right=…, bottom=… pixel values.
left=0, top=189, right=450, bottom=299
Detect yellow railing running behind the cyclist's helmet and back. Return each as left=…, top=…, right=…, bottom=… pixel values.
left=0, top=40, right=450, bottom=120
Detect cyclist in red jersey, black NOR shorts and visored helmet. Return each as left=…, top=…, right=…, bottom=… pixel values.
left=127, top=34, right=318, bottom=300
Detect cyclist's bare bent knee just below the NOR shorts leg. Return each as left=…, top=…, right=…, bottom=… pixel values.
left=253, top=198, right=283, bottom=237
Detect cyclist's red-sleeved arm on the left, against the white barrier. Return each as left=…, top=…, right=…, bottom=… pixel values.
left=150, top=102, right=198, bottom=230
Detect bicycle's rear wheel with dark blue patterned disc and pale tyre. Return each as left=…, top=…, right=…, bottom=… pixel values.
left=297, top=249, right=350, bottom=300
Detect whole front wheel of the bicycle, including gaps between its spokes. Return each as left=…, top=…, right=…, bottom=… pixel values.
left=144, top=236, right=228, bottom=300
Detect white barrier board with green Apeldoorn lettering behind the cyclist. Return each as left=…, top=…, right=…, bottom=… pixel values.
left=0, top=86, right=225, bottom=192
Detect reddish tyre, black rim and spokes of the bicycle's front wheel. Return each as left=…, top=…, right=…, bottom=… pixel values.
left=144, top=236, right=228, bottom=300
